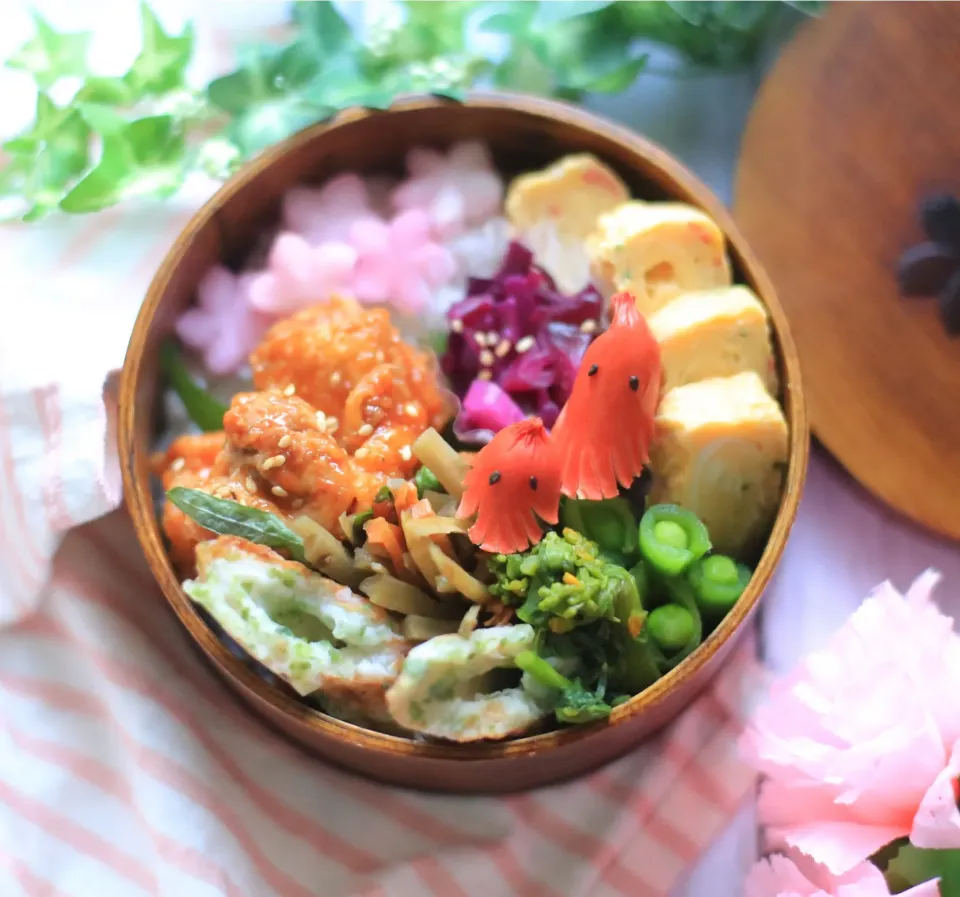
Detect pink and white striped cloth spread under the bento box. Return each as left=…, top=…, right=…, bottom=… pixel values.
left=0, top=4, right=754, bottom=897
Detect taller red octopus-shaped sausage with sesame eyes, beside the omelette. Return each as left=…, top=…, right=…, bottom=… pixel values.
left=552, top=293, right=662, bottom=501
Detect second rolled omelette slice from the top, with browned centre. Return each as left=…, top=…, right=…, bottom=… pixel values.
left=587, top=202, right=731, bottom=317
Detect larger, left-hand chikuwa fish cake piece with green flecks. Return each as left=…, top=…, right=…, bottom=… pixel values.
left=183, top=536, right=410, bottom=704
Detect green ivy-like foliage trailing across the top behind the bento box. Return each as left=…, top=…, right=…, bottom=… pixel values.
left=0, top=0, right=822, bottom=221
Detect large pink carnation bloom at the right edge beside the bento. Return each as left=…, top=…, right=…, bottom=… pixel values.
left=742, top=570, right=960, bottom=880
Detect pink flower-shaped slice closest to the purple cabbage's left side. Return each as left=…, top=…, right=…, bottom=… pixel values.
left=350, top=209, right=456, bottom=313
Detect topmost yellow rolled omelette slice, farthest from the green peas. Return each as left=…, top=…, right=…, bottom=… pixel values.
left=504, top=153, right=630, bottom=293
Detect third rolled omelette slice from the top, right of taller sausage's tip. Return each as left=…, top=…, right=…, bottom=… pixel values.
left=648, top=285, right=778, bottom=396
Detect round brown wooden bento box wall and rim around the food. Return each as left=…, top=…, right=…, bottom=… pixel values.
left=119, top=95, right=809, bottom=793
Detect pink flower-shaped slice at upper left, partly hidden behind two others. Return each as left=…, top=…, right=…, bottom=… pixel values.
left=283, top=173, right=380, bottom=246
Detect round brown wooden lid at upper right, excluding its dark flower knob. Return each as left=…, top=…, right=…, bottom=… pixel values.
left=735, top=3, right=960, bottom=539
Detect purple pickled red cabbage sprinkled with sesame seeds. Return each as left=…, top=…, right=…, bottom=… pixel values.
left=441, top=242, right=603, bottom=442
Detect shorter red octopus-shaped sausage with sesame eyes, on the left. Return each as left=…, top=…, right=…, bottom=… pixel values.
left=457, top=417, right=560, bottom=554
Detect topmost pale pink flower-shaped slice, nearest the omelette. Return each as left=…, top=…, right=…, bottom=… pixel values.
left=392, top=142, right=504, bottom=240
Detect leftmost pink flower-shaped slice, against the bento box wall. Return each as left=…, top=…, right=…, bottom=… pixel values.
left=176, top=265, right=273, bottom=375
